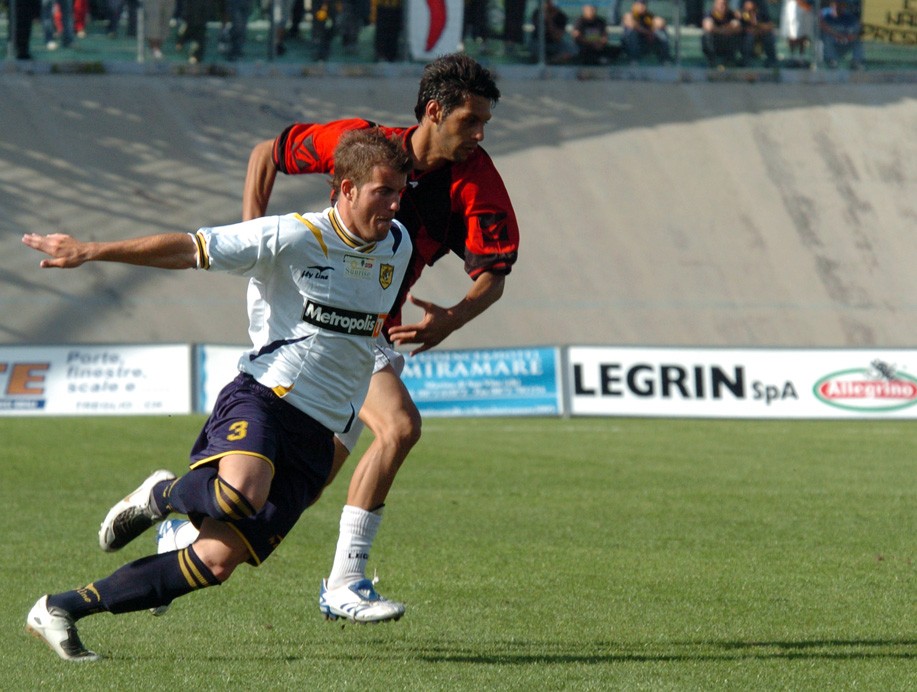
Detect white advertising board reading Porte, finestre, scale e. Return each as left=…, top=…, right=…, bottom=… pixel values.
left=0, top=345, right=191, bottom=416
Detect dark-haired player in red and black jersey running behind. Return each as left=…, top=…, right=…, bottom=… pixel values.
left=243, top=54, right=519, bottom=621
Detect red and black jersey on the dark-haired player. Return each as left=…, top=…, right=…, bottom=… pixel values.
left=273, top=118, right=519, bottom=327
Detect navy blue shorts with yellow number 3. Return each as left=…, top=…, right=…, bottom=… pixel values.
left=191, top=374, right=334, bottom=565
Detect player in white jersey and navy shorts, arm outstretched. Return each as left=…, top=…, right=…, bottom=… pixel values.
left=23, top=129, right=412, bottom=661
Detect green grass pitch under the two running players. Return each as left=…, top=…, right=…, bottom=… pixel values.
left=0, top=416, right=917, bottom=691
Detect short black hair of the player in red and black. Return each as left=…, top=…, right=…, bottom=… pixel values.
left=414, top=53, right=500, bottom=122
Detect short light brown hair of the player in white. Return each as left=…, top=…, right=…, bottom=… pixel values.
left=331, top=127, right=413, bottom=193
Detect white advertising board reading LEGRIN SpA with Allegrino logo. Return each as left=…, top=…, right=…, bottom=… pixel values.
left=566, top=347, right=917, bottom=418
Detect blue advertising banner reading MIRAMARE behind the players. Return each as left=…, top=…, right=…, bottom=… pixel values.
left=401, top=348, right=563, bottom=416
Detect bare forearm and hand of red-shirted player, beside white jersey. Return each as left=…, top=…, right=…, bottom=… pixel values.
left=389, top=272, right=506, bottom=356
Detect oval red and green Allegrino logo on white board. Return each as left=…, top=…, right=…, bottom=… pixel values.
left=812, top=360, right=917, bottom=412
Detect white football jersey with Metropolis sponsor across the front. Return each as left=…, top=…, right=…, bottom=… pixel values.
left=193, top=207, right=412, bottom=432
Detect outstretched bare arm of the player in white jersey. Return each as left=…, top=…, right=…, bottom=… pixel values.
left=22, top=233, right=197, bottom=269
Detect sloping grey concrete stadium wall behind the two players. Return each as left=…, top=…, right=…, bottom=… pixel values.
left=0, top=74, right=917, bottom=348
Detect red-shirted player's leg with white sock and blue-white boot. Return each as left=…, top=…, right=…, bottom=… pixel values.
left=319, top=367, right=421, bottom=622
